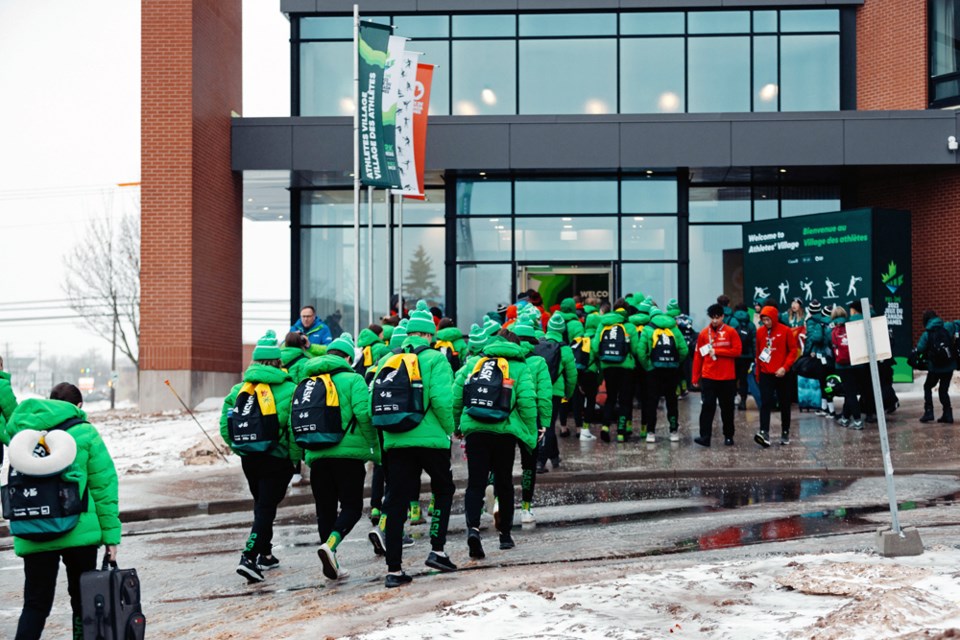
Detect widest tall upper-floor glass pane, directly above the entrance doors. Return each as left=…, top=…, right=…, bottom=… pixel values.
left=519, top=39, right=617, bottom=114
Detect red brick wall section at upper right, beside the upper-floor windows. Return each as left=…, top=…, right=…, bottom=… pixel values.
left=857, top=0, right=927, bottom=111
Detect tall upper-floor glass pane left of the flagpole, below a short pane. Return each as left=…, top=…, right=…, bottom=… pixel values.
left=300, top=42, right=354, bottom=116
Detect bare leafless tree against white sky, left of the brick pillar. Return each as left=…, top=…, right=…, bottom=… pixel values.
left=63, top=206, right=140, bottom=371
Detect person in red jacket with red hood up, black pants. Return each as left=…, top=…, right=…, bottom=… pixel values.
left=753, top=305, right=797, bottom=448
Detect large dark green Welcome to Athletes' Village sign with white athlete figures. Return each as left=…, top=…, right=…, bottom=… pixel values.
left=743, top=209, right=913, bottom=379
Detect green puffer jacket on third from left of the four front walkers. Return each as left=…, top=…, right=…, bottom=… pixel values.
left=377, top=336, right=453, bottom=451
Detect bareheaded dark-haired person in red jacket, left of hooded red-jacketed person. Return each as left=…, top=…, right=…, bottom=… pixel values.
left=692, top=304, right=743, bottom=447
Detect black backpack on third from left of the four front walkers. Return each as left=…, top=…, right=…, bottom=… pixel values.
left=370, top=347, right=429, bottom=433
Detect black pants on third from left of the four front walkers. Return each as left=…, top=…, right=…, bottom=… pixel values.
left=383, top=447, right=456, bottom=571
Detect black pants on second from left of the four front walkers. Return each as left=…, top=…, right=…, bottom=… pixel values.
left=310, top=458, right=367, bottom=543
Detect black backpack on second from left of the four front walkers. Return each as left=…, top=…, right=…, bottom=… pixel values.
left=290, top=373, right=355, bottom=451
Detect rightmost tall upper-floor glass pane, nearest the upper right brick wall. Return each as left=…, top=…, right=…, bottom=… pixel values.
left=780, top=36, right=840, bottom=111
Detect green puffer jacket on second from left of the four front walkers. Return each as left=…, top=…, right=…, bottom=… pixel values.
left=303, top=356, right=380, bottom=465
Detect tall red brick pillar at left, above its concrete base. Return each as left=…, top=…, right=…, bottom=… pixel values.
left=140, top=0, right=242, bottom=372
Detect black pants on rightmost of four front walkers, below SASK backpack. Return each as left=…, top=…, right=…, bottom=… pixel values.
left=464, top=431, right=517, bottom=533
